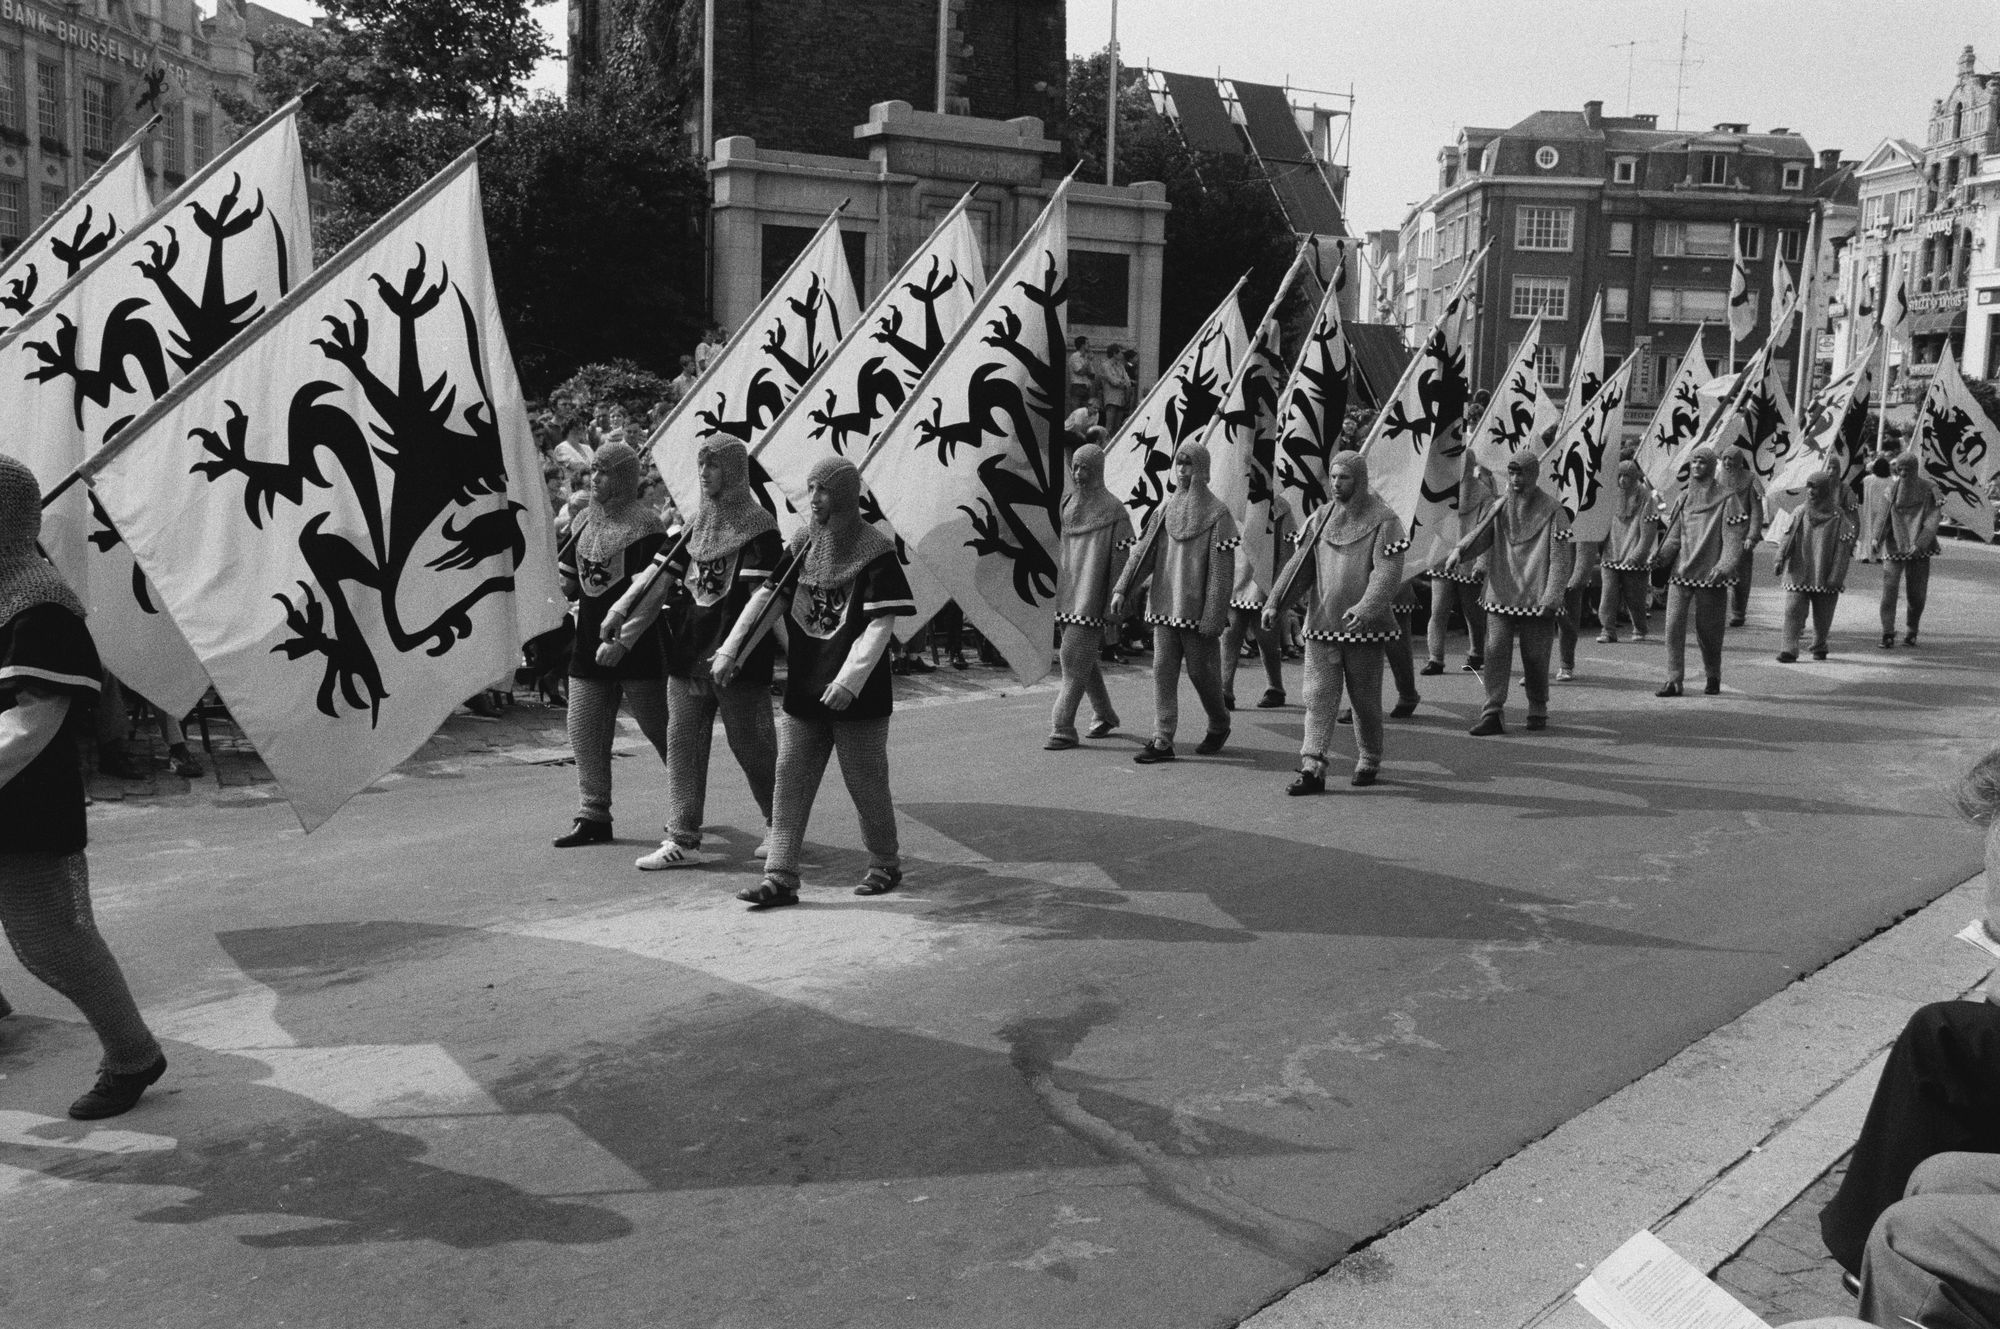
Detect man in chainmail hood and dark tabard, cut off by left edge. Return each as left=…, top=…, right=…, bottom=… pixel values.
left=0, top=452, right=166, bottom=1121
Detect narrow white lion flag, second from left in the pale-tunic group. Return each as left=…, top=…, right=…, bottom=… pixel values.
left=1208, top=306, right=1302, bottom=608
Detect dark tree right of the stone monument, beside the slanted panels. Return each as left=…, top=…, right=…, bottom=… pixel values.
left=1068, top=52, right=1304, bottom=366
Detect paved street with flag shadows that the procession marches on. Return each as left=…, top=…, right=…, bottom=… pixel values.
left=0, top=546, right=2000, bottom=1329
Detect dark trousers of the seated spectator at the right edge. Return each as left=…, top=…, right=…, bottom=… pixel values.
left=1820, top=1001, right=2000, bottom=1273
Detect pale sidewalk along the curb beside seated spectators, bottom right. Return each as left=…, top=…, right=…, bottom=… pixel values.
left=1244, top=877, right=1990, bottom=1329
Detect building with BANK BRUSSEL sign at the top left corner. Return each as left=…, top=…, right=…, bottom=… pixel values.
left=0, top=0, right=296, bottom=252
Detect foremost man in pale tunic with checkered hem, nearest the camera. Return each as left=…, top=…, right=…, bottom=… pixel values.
left=1262, top=452, right=1410, bottom=795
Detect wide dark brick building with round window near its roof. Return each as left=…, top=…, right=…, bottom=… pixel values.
left=1400, top=102, right=1838, bottom=426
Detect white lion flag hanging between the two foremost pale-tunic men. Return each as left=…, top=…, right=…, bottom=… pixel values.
left=1362, top=280, right=1478, bottom=568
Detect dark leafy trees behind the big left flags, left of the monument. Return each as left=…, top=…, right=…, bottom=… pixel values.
left=230, top=0, right=706, bottom=394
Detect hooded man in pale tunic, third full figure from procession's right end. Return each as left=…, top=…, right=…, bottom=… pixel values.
left=1654, top=446, right=1756, bottom=697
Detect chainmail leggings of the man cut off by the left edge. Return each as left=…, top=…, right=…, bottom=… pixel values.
left=0, top=851, right=160, bottom=1075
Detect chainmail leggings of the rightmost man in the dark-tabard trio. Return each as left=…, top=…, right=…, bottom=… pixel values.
left=764, top=715, right=902, bottom=887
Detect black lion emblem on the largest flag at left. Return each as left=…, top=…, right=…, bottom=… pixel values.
left=190, top=246, right=528, bottom=725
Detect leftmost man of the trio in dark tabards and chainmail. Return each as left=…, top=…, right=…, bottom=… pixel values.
left=554, top=438, right=666, bottom=849
